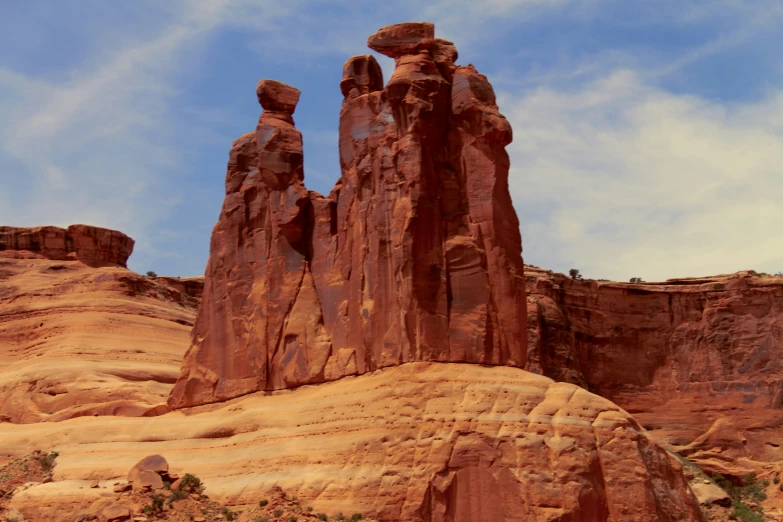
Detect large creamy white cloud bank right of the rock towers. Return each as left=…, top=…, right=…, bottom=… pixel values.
left=508, top=70, right=783, bottom=281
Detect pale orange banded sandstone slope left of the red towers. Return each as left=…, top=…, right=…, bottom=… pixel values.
left=0, top=236, right=200, bottom=423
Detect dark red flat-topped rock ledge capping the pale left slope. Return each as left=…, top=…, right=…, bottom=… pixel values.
left=0, top=225, right=134, bottom=268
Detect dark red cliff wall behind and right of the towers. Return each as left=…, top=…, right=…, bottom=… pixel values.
left=526, top=267, right=783, bottom=468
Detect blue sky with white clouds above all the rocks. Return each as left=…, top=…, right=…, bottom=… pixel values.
left=0, top=0, right=783, bottom=281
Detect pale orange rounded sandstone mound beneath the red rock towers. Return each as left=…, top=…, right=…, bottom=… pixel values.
left=0, top=362, right=703, bottom=522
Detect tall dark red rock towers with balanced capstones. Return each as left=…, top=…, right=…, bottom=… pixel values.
left=169, top=23, right=527, bottom=407
